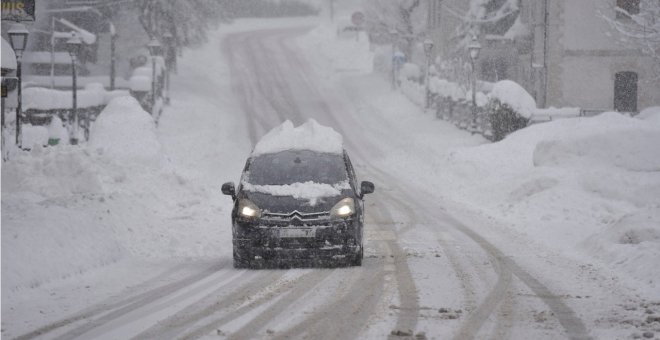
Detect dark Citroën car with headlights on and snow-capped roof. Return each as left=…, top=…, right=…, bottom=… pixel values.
left=222, top=120, right=374, bottom=268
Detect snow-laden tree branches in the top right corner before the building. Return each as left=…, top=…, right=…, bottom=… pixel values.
left=602, top=0, right=660, bottom=77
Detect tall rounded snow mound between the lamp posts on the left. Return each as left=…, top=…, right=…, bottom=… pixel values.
left=89, top=97, right=162, bottom=166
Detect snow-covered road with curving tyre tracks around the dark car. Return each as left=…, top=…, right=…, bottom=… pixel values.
left=3, top=19, right=656, bottom=339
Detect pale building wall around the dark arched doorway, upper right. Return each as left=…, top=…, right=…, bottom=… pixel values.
left=546, top=0, right=660, bottom=110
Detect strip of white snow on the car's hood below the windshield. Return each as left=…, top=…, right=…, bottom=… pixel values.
left=242, top=181, right=350, bottom=206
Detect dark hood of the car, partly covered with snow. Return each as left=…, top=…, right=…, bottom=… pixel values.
left=243, top=190, right=353, bottom=214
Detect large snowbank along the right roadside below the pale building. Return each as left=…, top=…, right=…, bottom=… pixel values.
left=447, top=112, right=660, bottom=289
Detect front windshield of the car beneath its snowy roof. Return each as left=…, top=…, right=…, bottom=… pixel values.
left=247, top=150, right=348, bottom=185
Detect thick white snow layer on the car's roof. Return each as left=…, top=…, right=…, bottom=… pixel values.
left=252, top=119, right=344, bottom=156
